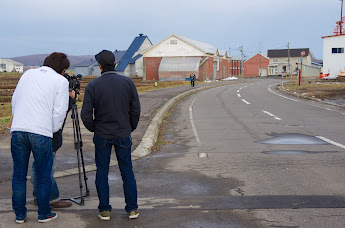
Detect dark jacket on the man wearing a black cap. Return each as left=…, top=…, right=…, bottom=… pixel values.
left=81, top=71, right=140, bottom=139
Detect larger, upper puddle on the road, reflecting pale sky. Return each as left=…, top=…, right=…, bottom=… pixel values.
left=256, top=133, right=329, bottom=145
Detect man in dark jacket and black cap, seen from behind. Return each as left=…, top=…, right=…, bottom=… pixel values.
left=81, top=50, right=140, bottom=220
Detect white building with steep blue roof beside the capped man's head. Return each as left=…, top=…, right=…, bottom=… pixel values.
left=116, top=34, right=152, bottom=77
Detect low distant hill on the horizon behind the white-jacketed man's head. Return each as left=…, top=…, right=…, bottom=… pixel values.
left=11, top=54, right=95, bottom=69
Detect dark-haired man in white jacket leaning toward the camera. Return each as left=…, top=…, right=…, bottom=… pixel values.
left=11, top=52, right=70, bottom=223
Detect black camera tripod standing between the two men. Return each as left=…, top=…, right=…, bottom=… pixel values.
left=64, top=95, right=89, bottom=205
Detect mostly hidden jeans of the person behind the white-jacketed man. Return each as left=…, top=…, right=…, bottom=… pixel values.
left=31, top=151, right=60, bottom=203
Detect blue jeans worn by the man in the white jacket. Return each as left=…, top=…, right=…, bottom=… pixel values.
left=11, top=131, right=53, bottom=219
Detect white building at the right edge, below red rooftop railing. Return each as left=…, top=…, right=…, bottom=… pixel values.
left=322, top=34, right=345, bottom=79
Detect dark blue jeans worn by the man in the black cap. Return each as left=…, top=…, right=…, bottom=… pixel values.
left=93, top=135, right=138, bottom=212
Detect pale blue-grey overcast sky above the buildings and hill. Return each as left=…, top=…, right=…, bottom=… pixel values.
left=0, top=0, right=345, bottom=59
